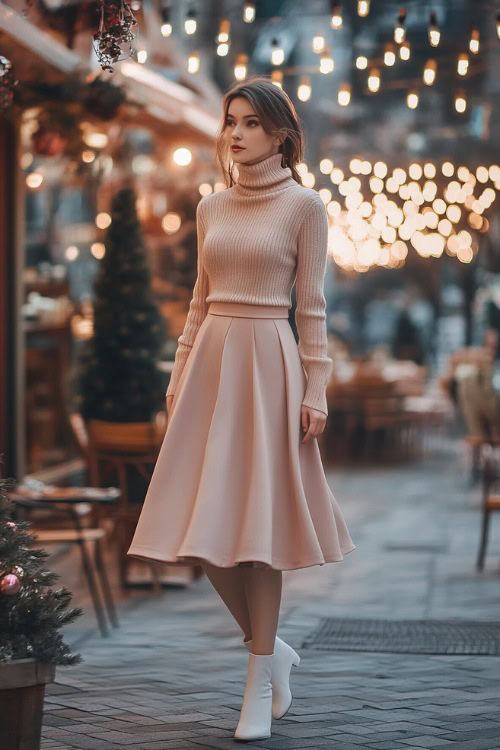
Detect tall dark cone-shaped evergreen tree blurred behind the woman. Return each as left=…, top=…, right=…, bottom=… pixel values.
left=75, top=188, right=166, bottom=422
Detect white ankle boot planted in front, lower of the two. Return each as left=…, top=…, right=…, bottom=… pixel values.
left=234, top=652, right=273, bottom=742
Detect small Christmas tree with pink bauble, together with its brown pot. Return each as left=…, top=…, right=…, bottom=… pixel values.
left=0, top=478, right=82, bottom=750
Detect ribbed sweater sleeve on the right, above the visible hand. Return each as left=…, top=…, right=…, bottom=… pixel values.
left=295, top=195, right=333, bottom=415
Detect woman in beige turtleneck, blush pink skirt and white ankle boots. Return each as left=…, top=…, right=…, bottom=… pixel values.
left=128, top=76, right=355, bottom=741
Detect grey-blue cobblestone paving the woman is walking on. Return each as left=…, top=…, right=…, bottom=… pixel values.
left=42, top=443, right=500, bottom=750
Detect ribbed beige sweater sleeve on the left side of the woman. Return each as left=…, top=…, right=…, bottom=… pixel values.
left=165, top=198, right=208, bottom=396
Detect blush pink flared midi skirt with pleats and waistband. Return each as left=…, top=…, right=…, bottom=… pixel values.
left=127, top=302, right=355, bottom=570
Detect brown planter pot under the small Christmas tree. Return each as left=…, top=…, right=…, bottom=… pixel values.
left=0, top=659, right=56, bottom=750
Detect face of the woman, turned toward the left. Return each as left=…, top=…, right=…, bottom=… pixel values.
left=224, top=96, right=280, bottom=164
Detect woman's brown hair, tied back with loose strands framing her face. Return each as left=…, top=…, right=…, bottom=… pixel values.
left=215, top=76, right=304, bottom=187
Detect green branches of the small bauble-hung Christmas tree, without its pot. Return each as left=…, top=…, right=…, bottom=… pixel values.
left=0, top=479, right=82, bottom=664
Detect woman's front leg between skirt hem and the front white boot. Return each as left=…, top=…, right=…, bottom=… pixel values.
left=242, top=567, right=282, bottom=654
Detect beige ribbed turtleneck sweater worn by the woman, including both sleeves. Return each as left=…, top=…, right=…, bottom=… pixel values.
left=166, top=149, right=332, bottom=414
